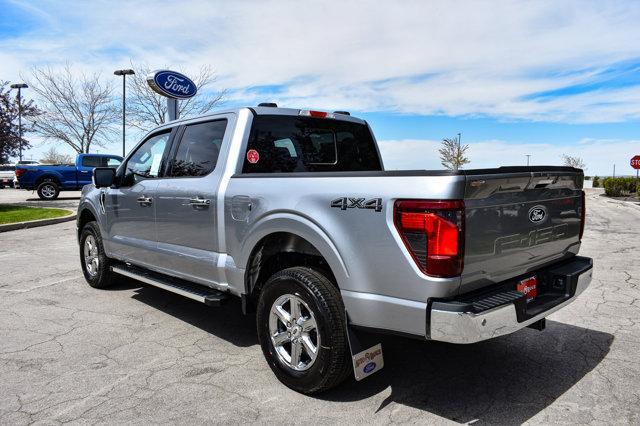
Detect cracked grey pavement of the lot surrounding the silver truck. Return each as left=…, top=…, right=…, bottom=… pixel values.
left=0, top=190, right=640, bottom=425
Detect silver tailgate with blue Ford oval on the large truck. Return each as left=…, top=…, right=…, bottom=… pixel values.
left=460, top=167, right=584, bottom=293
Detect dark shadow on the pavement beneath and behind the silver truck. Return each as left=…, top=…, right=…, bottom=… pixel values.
left=117, top=282, right=613, bottom=424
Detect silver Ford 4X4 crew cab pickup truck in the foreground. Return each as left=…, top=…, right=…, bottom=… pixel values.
left=77, top=104, right=592, bottom=393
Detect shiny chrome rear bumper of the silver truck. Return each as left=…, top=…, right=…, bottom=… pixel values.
left=429, top=258, right=593, bottom=344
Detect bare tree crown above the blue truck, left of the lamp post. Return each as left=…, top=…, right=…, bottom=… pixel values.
left=27, top=64, right=118, bottom=153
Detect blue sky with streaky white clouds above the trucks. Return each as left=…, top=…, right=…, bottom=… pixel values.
left=0, top=0, right=640, bottom=175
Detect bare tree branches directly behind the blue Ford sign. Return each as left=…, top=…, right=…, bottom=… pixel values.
left=127, top=63, right=225, bottom=131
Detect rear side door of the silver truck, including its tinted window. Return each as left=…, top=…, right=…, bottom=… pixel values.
left=156, top=114, right=234, bottom=286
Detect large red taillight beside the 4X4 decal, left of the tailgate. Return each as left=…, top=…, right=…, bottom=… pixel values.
left=394, top=200, right=464, bottom=277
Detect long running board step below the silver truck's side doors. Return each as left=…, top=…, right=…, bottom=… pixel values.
left=111, top=265, right=228, bottom=306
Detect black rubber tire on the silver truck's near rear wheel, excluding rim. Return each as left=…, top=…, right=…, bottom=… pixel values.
left=256, top=267, right=352, bottom=394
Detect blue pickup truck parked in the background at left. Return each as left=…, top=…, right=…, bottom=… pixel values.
left=16, top=154, right=122, bottom=200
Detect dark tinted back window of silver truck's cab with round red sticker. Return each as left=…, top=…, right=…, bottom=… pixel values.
left=242, top=115, right=382, bottom=173
